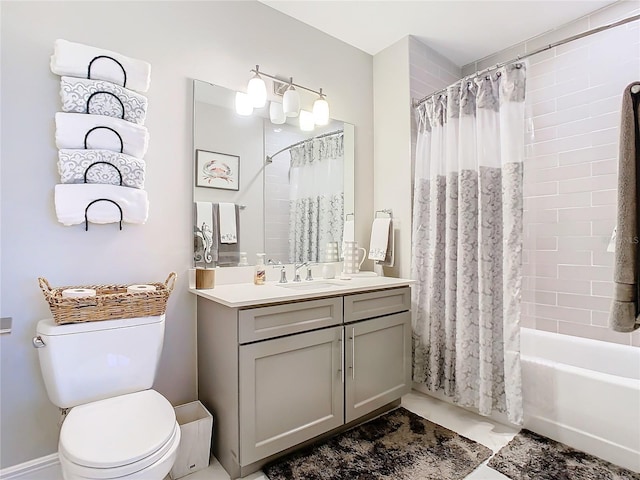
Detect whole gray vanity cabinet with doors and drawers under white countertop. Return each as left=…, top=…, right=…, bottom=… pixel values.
left=198, top=287, right=411, bottom=479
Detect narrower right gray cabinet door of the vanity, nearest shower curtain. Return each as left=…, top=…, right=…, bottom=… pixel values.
left=344, top=312, right=411, bottom=422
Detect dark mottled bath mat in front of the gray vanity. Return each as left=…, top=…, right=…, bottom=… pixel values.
left=262, top=407, right=492, bottom=480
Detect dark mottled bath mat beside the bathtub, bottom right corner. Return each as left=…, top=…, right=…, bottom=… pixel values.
left=488, top=430, right=640, bottom=480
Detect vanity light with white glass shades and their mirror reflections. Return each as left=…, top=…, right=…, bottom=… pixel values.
left=236, top=65, right=329, bottom=126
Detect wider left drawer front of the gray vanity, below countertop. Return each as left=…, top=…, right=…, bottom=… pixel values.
left=238, top=297, right=342, bottom=343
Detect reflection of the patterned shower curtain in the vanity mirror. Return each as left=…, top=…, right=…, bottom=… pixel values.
left=289, top=133, right=344, bottom=262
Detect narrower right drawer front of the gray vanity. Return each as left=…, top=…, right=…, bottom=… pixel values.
left=344, top=287, right=411, bottom=322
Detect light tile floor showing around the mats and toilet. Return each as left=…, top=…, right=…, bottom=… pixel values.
left=20, top=391, right=518, bottom=480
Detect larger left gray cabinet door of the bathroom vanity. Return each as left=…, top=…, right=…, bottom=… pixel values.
left=239, top=326, right=344, bottom=465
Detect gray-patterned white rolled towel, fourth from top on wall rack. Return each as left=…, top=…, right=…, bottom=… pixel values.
left=58, top=148, right=145, bottom=188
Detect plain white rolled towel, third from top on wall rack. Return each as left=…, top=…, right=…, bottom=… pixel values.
left=56, top=112, right=149, bottom=158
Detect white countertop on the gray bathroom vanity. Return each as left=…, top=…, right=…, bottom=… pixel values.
left=189, top=276, right=414, bottom=308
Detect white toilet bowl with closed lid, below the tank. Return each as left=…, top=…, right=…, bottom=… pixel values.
left=58, top=390, right=180, bottom=480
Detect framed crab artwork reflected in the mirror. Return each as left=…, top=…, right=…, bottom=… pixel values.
left=196, top=150, right=240, bottom=190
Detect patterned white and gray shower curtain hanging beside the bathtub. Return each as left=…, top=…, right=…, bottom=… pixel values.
left=412, top=63, right=526, bottom=424
